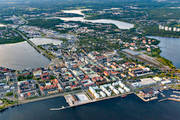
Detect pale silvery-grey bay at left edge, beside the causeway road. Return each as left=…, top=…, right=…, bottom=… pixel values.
left=0, top=42, right=50, bottom=70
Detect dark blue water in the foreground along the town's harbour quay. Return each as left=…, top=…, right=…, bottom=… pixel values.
left=0, top=95, right=180, bottom=120
